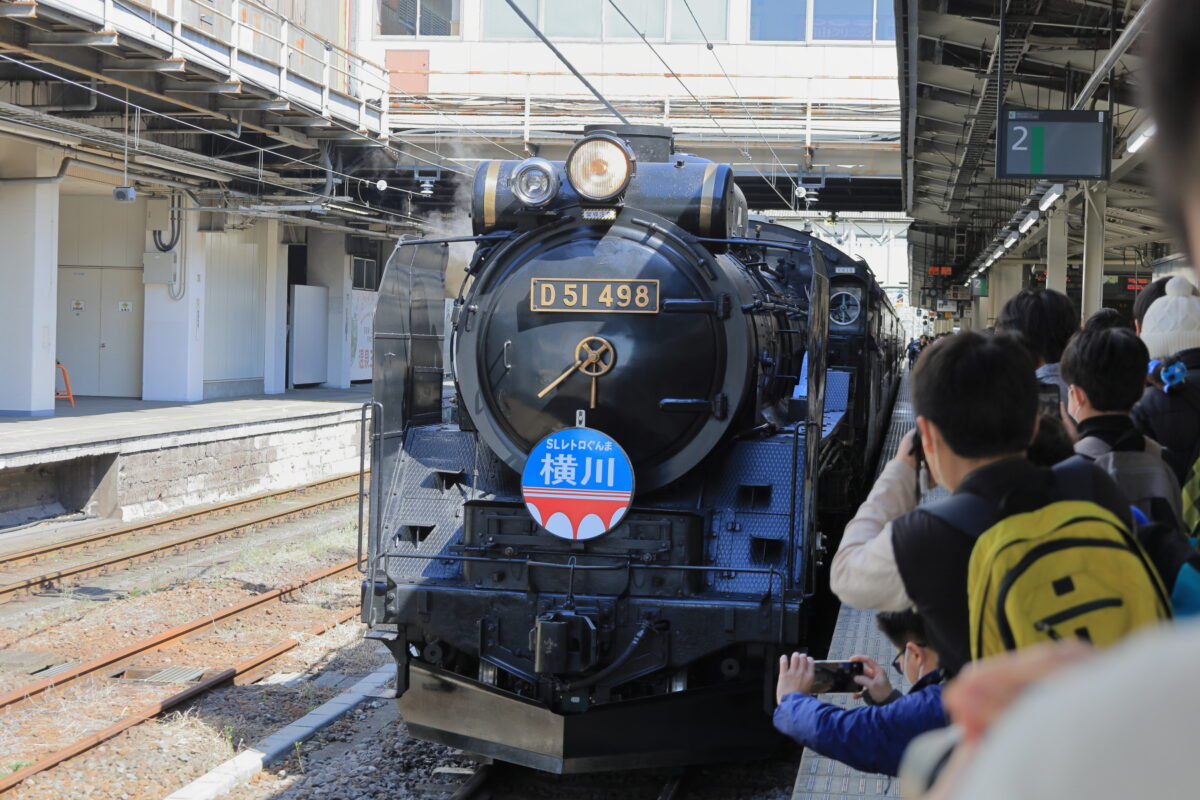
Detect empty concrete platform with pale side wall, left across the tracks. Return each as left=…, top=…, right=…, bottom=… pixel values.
left=0, top=386, right=371, bottom=535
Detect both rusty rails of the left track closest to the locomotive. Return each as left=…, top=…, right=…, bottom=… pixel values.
left=0, top=559, right=360, bottom=794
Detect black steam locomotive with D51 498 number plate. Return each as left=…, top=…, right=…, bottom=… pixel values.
left=362, top=126, right=902, bottom=772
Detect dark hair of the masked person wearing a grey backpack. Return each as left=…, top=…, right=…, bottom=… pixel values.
left=1058, top=327, right=1150, bottom=413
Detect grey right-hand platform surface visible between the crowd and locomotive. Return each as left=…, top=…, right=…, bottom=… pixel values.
left=792, top=372, right=946, bottom=800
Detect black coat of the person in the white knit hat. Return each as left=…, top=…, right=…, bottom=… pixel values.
left=1129, top=348, right=1200, bottom=486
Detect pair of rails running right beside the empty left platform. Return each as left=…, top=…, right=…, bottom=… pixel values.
left=0, top=473, right=360, bottom=603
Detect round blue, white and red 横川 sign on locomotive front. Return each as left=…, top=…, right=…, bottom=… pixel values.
left=521, top=427, right=634, bottom=540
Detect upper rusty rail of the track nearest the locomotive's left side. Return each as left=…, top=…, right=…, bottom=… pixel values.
left=0, top=559, right=358, bottom=709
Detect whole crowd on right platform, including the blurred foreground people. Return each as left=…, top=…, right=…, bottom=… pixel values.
left=775, top=0, right=1200, bottom=800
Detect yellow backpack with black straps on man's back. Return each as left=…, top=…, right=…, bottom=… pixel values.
left=924, top=458, right=1171, bottom=658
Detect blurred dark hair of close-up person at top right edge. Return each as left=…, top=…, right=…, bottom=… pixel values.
left=1144, top=0, right=1200, bottom=264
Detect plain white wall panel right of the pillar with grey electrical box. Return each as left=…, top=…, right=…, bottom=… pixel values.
left=204, top=224, right=266, bottom=397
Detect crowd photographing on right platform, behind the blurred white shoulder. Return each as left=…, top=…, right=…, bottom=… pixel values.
left=775, top=276, right=1200, bottom=798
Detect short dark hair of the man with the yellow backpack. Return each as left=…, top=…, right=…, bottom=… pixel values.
left=912, top=331, right=1038, bottom=458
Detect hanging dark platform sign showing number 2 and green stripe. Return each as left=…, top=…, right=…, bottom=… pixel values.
left=996, top=109, right=1112, bottom=180
